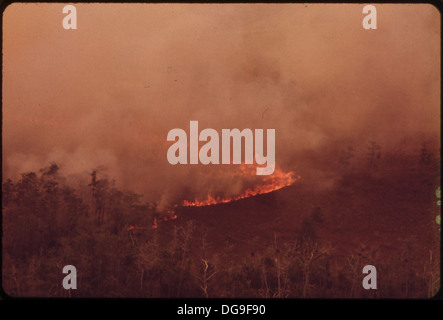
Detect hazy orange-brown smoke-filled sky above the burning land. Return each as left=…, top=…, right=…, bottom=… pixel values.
left=2, top=3, right=441, bottom=205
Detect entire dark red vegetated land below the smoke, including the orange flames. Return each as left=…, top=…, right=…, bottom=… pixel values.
left=2, top=144, right=440, bottom=298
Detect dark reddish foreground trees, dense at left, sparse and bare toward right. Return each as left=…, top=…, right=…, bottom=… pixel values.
left=2, top=164, right=440, bottom=298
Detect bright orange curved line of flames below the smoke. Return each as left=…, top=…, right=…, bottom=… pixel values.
left=182, top=166, right=300, bottom=207
